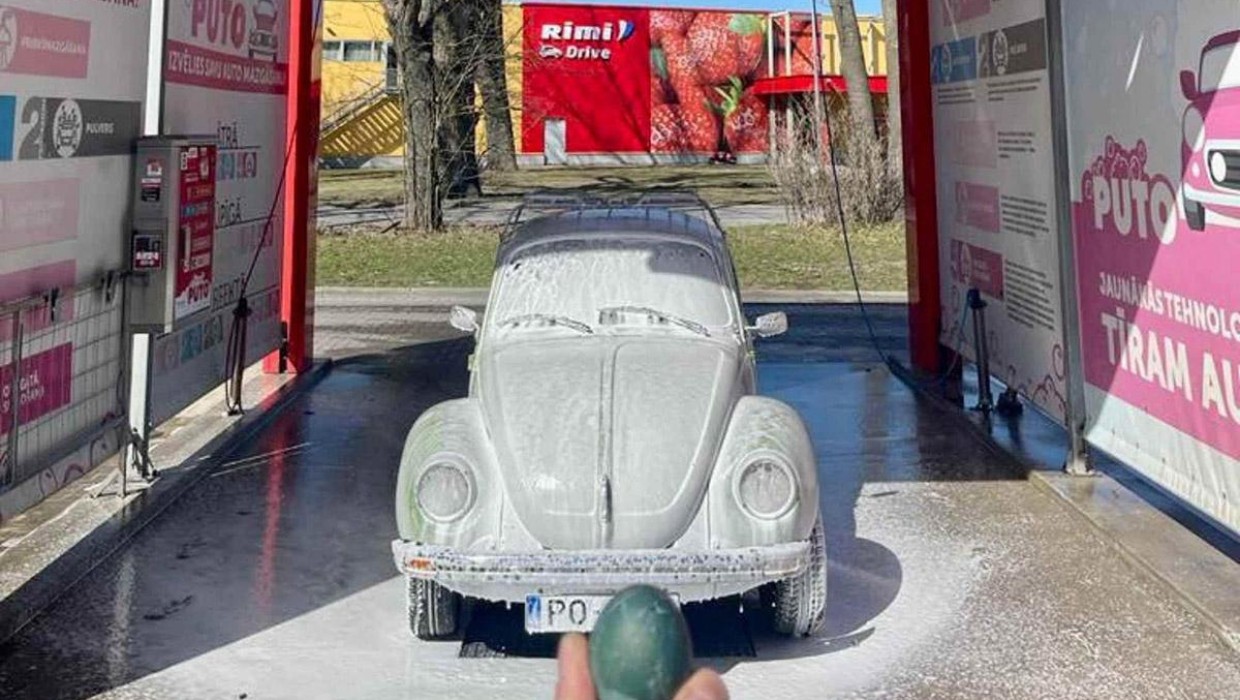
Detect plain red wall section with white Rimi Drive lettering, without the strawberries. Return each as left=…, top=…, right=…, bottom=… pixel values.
left=521, top=4, right=650, bottom=154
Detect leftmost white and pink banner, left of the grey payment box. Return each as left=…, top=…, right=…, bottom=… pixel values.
left=0, top=0, right=151, bottom=512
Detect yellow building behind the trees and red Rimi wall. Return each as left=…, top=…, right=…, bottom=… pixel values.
left=320, top=0, right=887, bottom=167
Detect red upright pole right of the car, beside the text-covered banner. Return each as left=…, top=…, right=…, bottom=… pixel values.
left=898, top=0, right=944, bottom=373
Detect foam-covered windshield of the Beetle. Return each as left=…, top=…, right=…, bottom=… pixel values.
left=487, top=238, right=734, bottom=332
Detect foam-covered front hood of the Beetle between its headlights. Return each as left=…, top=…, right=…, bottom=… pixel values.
left=479, top=336, right=742, bottom=549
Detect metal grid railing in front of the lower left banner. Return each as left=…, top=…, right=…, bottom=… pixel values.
left=0, top=273, right=128, bottom=493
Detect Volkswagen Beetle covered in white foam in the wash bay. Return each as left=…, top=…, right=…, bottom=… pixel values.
left=392, top=193, right=827, bottom=639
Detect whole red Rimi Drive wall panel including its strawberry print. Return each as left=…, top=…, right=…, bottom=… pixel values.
left=521, top=2, right=769, bottom=156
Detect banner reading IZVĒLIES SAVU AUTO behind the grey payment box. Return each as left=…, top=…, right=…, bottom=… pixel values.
left=151, top=0, right=291, bottom=424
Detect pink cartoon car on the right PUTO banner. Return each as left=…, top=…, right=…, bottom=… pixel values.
left=1179, top=30, right=1240, bottom=230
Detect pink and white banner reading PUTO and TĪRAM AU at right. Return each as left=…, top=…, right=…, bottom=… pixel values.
left=1064, top=0, right=1240, bottom=532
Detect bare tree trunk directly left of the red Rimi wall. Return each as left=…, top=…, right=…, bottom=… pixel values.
left=475, top=0, right=517, bottom=170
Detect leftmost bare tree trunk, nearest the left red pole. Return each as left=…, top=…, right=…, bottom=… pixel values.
left=383, top=0, right=444, bottom=230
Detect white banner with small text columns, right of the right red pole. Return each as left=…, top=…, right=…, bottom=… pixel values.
left=926, top=0, right=1066, bottom=421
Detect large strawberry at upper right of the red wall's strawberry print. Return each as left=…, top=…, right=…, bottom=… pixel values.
left=687, top=12, right=766, bottom=84
